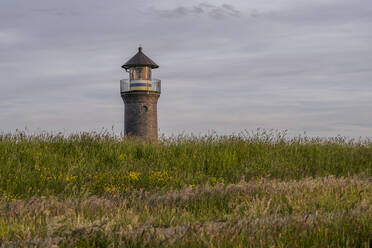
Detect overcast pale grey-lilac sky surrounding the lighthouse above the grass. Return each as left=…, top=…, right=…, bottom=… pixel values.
left=0, top=0, right=372, bottom=138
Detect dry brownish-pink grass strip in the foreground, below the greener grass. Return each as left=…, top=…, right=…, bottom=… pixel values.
left=0, top=176, right=372, bottom=247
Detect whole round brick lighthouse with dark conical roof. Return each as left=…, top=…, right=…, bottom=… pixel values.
left=120, top=47, right=161, bottom=140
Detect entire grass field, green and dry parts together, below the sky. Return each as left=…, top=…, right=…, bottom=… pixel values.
left=0, top=130, right=372, bottom=247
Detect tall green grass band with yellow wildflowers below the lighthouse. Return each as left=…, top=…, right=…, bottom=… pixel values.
left=0, top=131, right=372, bottom=199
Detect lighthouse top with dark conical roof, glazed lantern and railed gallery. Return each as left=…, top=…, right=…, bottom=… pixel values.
left=121, top=47, right=160, bottom=92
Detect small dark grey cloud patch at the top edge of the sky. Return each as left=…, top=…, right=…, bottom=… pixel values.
left=155, top=2, right=240, bottom=19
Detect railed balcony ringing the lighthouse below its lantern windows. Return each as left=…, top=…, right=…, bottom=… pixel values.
left=120, top=79, right=161, bottom=93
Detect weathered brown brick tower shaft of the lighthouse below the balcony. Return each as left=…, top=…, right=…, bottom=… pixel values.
left=122, top=91, right=160, bottom=140
